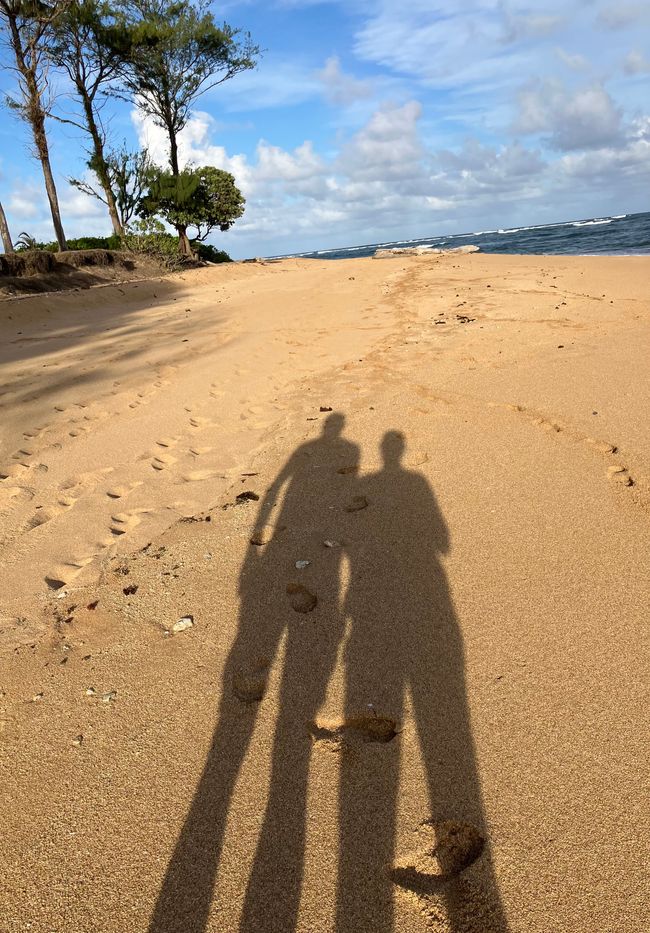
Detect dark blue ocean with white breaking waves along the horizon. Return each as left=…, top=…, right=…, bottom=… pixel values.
left=282, top=212, right=650, bottom=259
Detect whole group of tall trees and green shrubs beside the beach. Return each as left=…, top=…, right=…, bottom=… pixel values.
left=0, top=0, right=260, bottom=258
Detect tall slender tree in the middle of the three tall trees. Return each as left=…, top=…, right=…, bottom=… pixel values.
left=47, top=0, right=127, bottom=236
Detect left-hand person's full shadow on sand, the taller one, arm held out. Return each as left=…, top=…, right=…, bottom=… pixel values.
left=149, top=413, right=359, bottom=933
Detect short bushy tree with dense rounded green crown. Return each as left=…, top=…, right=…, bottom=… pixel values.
left=140, top=165, right=245, bottom=256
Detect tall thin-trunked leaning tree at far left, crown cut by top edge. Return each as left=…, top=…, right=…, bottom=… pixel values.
left=0, top=0, right=68, bottom=250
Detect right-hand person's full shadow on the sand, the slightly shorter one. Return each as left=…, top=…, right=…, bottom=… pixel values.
left=336, top=431, right=507, bottom=933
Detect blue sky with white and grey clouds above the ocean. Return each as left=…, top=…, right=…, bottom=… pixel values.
left=0, top=0, right=650, bottom=258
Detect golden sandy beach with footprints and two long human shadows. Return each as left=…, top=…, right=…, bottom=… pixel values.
left=0, top=253, right=650, bottom=933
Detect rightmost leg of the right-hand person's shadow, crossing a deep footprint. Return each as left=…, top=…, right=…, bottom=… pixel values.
left=402, top=632, right=508, bottom=933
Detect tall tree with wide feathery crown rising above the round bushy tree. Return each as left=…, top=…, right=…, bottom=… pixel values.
left=116, top=0, right=260, bottom=175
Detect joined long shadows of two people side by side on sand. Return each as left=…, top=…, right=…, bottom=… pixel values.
left=149, top=414, right=507, bottom=933
